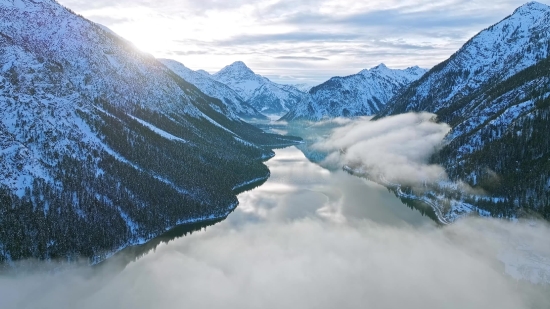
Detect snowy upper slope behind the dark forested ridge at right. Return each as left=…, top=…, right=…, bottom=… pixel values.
left=381, top=2, right=550, bottom=115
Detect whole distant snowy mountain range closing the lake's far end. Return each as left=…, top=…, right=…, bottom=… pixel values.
left=176, top=60, right=427, bottom=121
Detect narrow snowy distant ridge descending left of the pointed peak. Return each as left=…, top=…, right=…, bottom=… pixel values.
left=159, top=59, right=266, bottom=119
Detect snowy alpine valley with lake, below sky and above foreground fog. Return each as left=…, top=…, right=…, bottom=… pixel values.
left=0, top=0, right=550, bottom=292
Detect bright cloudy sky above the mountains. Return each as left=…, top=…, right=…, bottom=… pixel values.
left=59, top=0, right=536, bottom=84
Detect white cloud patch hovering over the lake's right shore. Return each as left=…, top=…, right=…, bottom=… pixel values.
left=313, top=113, right=450, bottom=184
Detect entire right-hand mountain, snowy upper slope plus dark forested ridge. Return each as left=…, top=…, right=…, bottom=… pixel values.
left=379, top=2, right=550, bottom=219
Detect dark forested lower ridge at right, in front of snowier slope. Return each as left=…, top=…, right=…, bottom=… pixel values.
left=434, top=54, right=550, bottom=219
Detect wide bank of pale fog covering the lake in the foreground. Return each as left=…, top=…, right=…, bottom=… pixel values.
left=0, top=218, right=550, bottom=309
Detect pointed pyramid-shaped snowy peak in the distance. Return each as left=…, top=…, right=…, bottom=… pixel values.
left=212, top=61, right=307, bottom=114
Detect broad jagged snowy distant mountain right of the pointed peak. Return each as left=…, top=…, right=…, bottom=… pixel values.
left=282, top=64, right=426, bottom=120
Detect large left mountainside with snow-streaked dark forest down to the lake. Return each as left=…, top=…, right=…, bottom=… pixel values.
left=0, top=0, right=298, bottom=262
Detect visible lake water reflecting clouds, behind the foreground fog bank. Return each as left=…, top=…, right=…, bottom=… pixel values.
left=229, top=147, right=433, bottom=226
